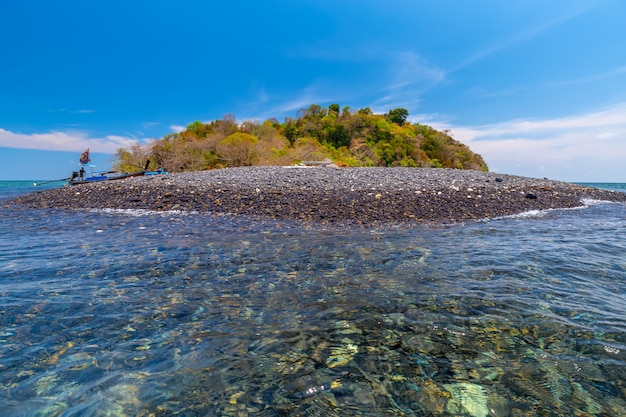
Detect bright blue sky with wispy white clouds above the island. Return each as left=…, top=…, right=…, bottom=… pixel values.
left=0, top=0, right=626, bottom=182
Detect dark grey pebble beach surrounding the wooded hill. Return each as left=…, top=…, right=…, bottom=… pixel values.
left=6, top=166, right=626, bottom=226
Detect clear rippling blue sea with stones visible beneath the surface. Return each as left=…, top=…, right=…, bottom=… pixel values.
left=0, top=181, right=626, bottom=417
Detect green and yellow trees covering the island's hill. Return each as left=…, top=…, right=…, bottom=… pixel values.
left=115, top=104, right=488, bottom=172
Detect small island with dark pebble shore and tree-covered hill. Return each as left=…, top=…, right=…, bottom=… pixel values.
left=8, top=104, right=626, bottom=227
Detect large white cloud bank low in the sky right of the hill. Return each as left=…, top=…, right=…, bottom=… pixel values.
left=411, top=103, right=626, bottom=182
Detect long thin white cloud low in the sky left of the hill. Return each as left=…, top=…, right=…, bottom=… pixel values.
left=0, top=129, right=138, bottom=153
